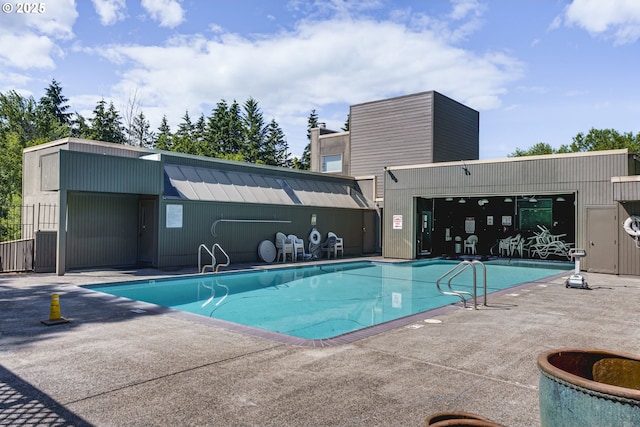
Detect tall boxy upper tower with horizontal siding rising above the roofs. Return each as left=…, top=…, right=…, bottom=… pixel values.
left=349, top=91, right=480, bottom=200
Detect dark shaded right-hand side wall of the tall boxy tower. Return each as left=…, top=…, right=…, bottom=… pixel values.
left=433, top=92, right=480, bottom=162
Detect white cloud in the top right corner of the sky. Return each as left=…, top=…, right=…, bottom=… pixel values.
left=564, top=0, right=640, bottom=44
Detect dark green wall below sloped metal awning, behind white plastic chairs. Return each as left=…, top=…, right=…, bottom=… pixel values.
left=158, top=200, right=368, bottom=267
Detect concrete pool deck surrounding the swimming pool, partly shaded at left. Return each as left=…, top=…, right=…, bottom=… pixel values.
left=0, top=260, right=640, bottom=427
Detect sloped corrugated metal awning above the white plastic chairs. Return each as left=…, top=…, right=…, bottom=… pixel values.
left=164, top=165, right=371, bottom=209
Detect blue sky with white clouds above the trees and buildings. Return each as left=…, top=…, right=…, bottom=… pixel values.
left=0, top=0, right=640, bottom=159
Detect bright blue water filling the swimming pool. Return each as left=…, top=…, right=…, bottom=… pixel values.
left=86, top=260, right=572, bottom=339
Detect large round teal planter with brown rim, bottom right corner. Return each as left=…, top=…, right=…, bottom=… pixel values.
left=538, top=349, right=640, bottom=427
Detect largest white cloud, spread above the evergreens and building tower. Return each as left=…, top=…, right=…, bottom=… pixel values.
left=87, top=5, right=522, bottom=152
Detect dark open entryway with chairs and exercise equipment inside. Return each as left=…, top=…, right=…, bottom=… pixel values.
left=416, top=193, right=576, bottom=260
